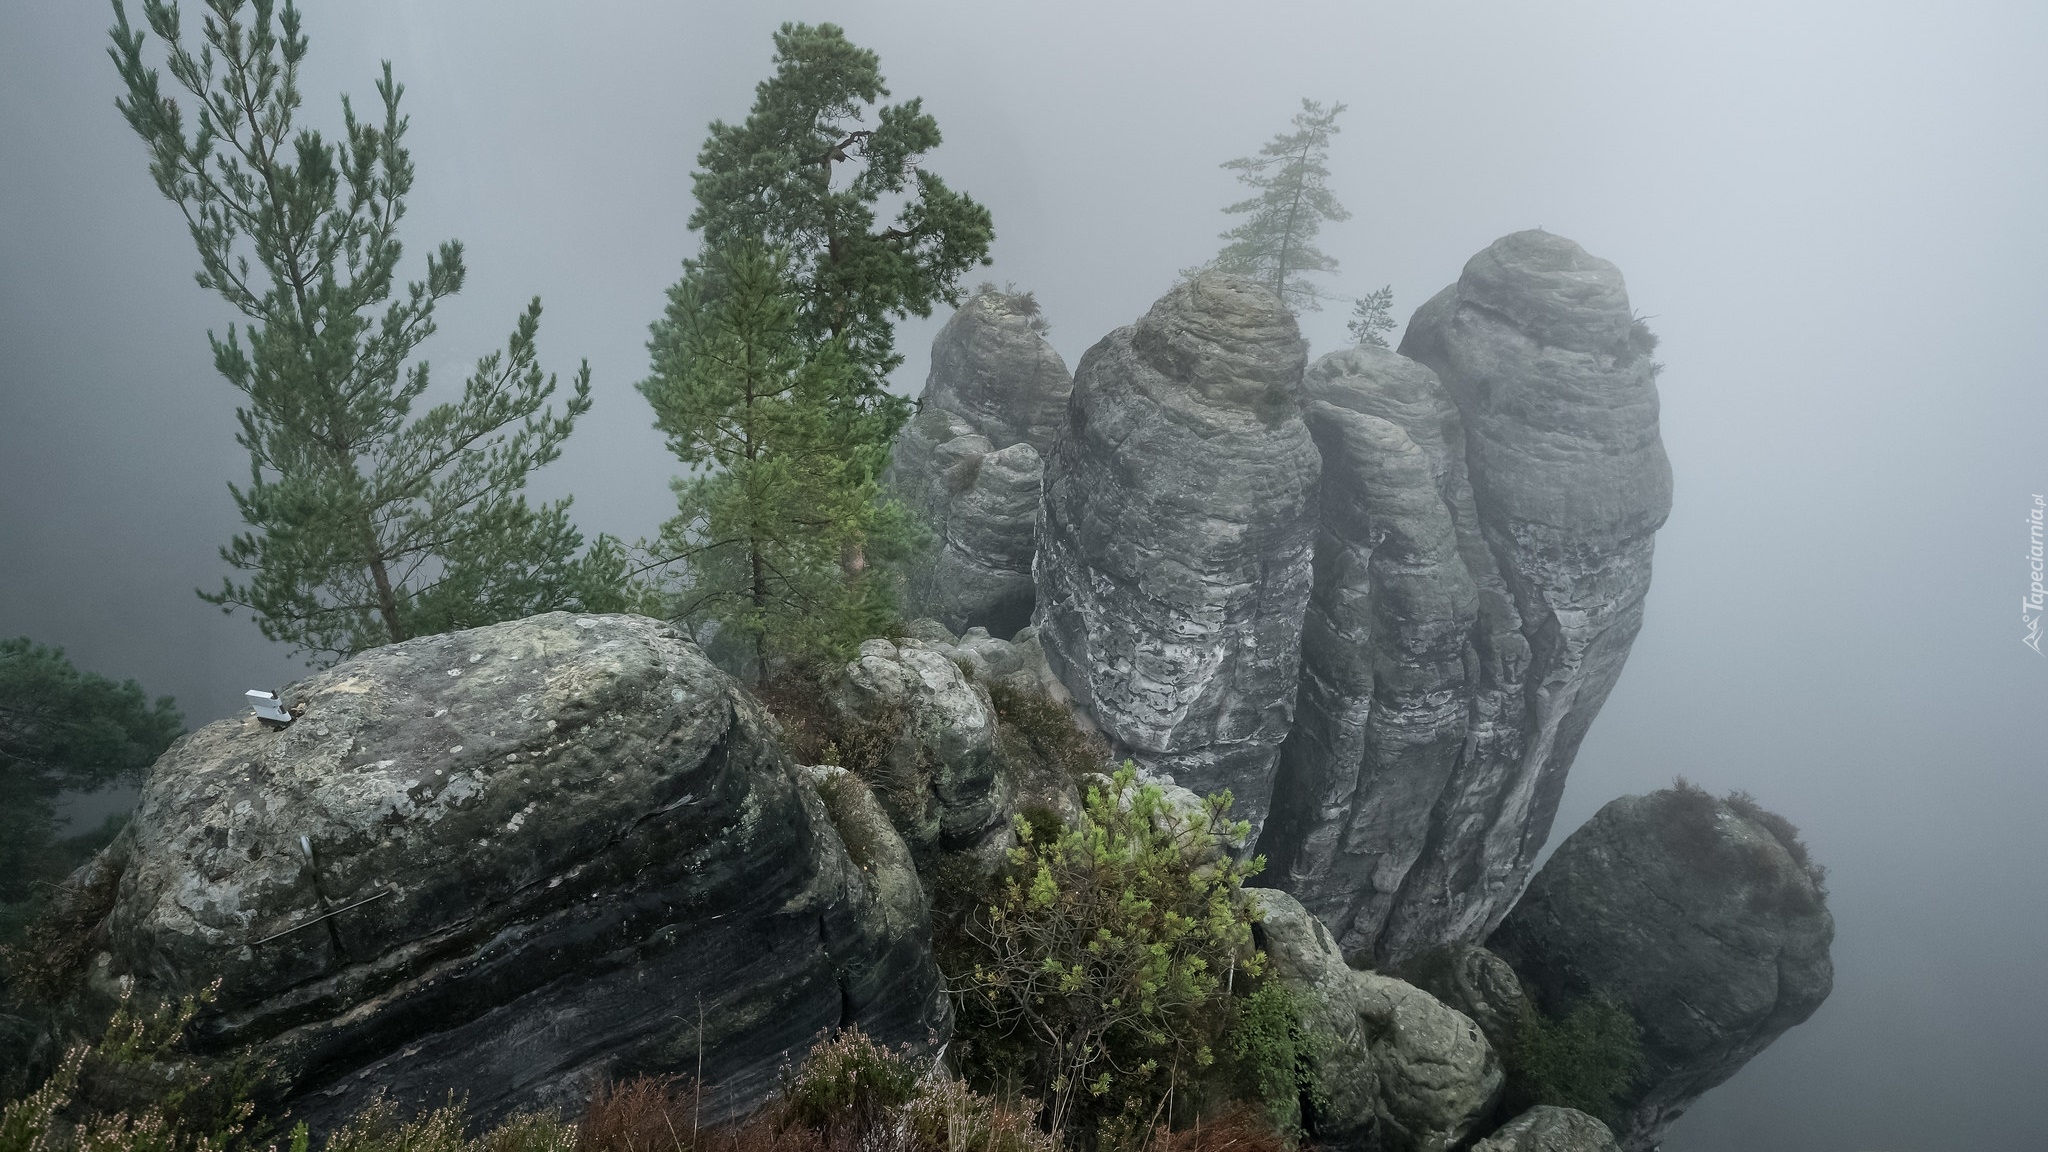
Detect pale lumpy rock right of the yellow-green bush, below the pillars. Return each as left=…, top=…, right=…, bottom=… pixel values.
left=1251, top=890, right=1503, bottom=1152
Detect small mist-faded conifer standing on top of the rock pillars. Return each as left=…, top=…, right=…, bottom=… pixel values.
left=1210, top=100, right=1352, bottom=310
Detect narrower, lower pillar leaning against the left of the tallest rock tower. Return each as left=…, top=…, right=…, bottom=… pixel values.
left=1262, top=348, right=1528, bottom=959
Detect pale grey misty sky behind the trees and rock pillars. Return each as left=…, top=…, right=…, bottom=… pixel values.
left=0, top=0, right=2048, bottom=1152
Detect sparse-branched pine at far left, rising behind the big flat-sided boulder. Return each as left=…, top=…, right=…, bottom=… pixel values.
left=109, top=0, right=627, bottom=658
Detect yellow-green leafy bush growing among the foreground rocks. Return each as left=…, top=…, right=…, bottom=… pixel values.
left=944, top=763, right=1274, bottom=1144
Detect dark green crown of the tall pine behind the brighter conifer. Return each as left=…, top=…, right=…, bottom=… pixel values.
left=690, top=25, right=995, bottom=426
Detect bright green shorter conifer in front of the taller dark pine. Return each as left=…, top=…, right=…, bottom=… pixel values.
left=639, top=242, right=903, bottom=678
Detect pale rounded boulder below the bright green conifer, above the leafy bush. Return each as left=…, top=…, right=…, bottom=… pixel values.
left=831, top=637, right=1010, bottom=851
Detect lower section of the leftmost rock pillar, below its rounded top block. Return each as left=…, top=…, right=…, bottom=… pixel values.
left=889, top=408, right=1044, bottom=637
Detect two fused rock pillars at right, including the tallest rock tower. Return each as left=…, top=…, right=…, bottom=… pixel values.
left=1262, top=232, right=1671, bottom=963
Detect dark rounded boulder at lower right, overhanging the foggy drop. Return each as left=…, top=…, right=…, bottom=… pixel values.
left=1487, top=789, right=1835, bottom=1152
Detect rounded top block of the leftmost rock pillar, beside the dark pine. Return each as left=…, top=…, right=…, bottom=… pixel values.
left=918, top=289, right=1073, bottom=455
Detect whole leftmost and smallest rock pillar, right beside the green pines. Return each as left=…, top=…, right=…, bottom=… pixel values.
left=889, top=289, right=1073, bottom=637
